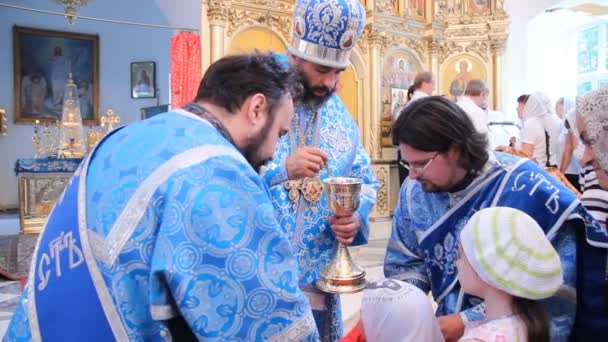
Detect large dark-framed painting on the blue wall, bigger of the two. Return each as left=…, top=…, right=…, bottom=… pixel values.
left=13, top=26, right=99, bottom=125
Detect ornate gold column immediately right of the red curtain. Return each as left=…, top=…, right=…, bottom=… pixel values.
left=207, top=0, right=230, bottom=64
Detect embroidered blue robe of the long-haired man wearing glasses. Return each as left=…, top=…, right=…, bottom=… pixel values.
left=384, top=153, right=608, bottom=341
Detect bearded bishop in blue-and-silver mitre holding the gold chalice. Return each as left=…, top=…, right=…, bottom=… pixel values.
left=264, top=0, right=379, bottom=341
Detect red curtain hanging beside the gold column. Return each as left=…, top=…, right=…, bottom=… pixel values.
left=171, top=32, right=202, bottom=108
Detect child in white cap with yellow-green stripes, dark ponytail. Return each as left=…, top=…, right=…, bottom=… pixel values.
left=456, top=207, right=563, bottom=342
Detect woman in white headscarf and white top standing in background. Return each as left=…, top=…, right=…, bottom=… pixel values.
left=520, top=92, right=562, bottom=167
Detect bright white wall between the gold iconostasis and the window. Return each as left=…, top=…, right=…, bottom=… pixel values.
left=502, top=0, right=605, bottom=115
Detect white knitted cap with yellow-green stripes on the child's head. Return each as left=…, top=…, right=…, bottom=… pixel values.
left=460, top=207, right=563, bottom=299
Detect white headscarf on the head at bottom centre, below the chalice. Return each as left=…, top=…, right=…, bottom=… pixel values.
left=361, top=279, right=444, bottom=342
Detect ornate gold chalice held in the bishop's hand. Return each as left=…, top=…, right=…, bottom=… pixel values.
left=316, top=177, right=367, bottom=293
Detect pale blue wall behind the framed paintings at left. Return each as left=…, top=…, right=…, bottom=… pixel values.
left=0, top=0, right=200, bottom=208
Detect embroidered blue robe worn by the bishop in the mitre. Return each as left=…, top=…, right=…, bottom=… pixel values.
left=263, top=55, right=379, bottom=341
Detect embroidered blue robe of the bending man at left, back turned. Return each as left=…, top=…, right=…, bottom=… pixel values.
left=5, top=110, right=318, bottom=341
